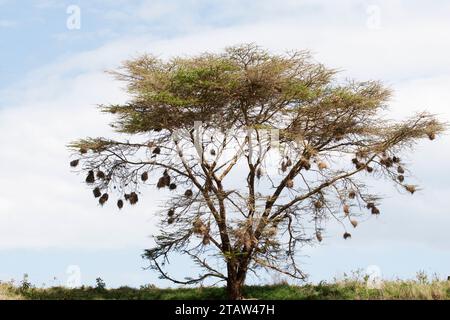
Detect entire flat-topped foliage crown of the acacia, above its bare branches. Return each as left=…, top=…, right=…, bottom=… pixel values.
left=98, top=45, right=437, bottom=149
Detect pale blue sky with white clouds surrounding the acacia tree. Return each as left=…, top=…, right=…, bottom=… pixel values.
left=0, top=0, right=450, bottom=286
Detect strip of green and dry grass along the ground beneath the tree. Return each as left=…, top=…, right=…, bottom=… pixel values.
left=0, top=279, right=450, bottom=300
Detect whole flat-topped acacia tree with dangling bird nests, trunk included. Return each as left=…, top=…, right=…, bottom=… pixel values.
left=70, top=45, right=445, bottom=299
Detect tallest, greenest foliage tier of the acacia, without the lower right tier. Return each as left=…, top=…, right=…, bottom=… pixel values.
left=103, top=45, right=335, bottom=133
